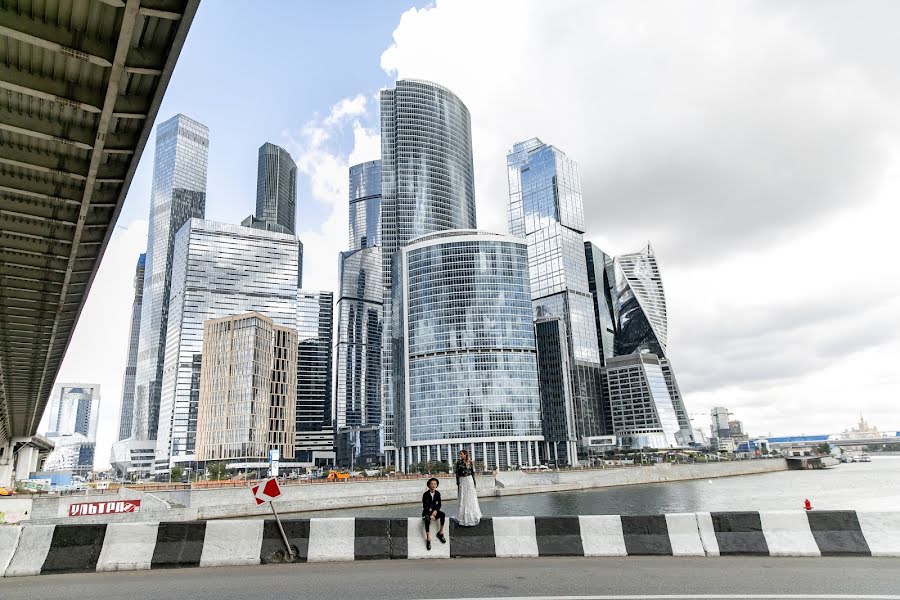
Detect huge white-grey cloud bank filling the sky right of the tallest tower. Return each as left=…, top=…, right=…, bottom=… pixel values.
left=381, top=0, right=900, bottom=433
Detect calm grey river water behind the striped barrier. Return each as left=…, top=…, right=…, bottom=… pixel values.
left=291, top=456, right=900, bottom=518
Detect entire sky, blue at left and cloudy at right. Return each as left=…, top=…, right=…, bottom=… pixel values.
left=45, top=0, right=900, bottom=465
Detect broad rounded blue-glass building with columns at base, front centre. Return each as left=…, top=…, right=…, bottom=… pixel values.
left=391, top=230, right=545, bottom=470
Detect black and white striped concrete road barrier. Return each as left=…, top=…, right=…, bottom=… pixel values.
left=0, top=511, right=900, bottom=577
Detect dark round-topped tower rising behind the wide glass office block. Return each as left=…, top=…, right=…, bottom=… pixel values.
left=251, top=142, right=297, bottom=234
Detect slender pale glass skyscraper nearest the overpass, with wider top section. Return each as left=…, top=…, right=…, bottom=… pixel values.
left=131, top=115, right=209, bottom=440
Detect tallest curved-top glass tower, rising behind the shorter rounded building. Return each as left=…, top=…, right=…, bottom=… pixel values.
left=381, top=79, right=477, bottom=462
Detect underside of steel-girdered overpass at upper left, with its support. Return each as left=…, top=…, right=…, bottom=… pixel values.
left=0, top=0, right=200, bottom=485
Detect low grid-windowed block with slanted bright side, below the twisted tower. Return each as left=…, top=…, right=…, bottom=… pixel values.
left=606, top=353, right=682, bottom=449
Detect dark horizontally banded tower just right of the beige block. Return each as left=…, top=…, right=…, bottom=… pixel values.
left=294, top=290, right=334, bottom=465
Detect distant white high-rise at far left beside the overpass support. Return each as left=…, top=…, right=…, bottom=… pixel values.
left=44, top=383, right=100, bottom=474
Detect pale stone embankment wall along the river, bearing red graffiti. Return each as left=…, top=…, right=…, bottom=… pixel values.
left=0, top=459, right=787, bottom=524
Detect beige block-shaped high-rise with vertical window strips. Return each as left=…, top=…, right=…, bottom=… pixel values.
left=197, top=312, right=297, bottom=468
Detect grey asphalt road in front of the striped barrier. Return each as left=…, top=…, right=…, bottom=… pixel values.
left=0, top=557, right=900, bottom=600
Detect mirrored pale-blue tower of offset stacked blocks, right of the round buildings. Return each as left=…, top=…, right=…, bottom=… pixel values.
left=507, top=138, right=606, bottom=464
